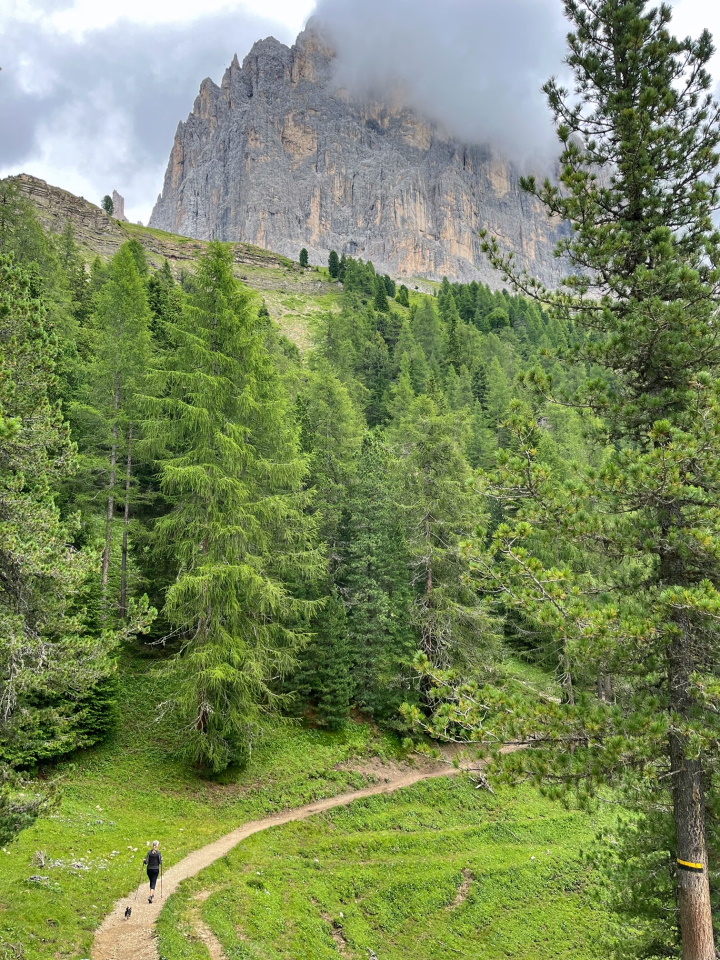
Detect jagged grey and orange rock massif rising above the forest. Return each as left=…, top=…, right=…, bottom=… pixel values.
left=150, top=22, right=559, bottom=286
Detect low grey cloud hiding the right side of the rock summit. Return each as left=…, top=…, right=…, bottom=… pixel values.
left=315, top=0, right=567, bottom=165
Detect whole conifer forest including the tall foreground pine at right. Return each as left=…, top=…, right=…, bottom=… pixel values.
left=0, top=0, right=720, bottom=960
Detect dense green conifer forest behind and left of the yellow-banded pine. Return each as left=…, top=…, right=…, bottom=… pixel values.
left=2, top=176, right=588, bottom=772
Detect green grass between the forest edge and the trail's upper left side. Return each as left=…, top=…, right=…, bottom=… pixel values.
left=0, top=666, right=397, bottom=960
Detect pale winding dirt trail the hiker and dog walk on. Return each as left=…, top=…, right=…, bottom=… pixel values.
left=92, top=763, right=466, bottom=960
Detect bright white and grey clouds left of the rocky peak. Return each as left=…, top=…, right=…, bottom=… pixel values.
left=0, top=0, right=311, bottom=221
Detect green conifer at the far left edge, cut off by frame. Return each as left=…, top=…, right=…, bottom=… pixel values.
left=0, top=255, right=113, bottom=836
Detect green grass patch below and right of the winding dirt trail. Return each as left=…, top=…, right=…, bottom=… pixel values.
left=159, top=776, right=608, bottom=960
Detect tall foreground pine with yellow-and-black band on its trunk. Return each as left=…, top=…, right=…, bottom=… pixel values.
left=462, top=0, right=720, bottom=960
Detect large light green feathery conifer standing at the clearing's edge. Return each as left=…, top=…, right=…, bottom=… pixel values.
left=146, top=243, right=319, bottom=771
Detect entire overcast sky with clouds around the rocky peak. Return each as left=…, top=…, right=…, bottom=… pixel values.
left=0, top=0, right=720, bottom=222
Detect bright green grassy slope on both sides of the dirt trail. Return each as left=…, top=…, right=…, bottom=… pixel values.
left=0, top=662, right=620, bottom=960
